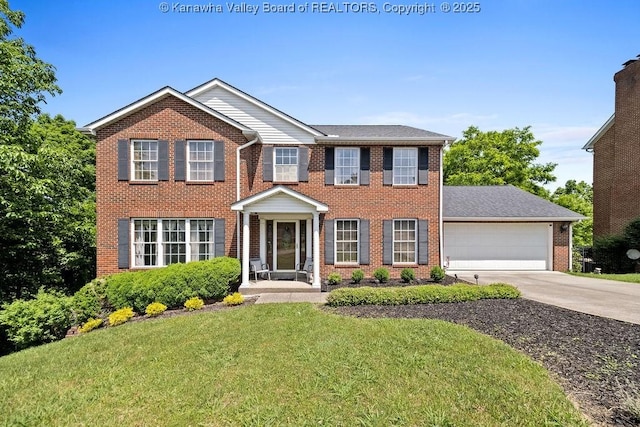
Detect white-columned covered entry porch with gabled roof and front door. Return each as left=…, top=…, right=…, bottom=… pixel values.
left=231, top=185, right=329, bottom=292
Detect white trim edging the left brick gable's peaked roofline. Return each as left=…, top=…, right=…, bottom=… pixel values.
left=83, top=86, right=251, bottom=132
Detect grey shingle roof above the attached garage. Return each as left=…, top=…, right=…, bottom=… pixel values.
left=442, top=185, right=586, bottom=221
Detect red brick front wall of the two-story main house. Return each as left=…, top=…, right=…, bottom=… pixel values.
left=96, top=93, right=441, bottom=278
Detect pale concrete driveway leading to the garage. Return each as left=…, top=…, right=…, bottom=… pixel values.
left=447, top=271, right=640, bottom=324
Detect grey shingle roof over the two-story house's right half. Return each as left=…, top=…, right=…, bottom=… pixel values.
left=310, top=125, right=453, bottom=139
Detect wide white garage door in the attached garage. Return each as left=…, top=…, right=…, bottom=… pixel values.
left=444, top=223, right=552, bottom=270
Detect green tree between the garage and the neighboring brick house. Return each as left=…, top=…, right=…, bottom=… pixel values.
left=550, top=180, right=593, bottom=247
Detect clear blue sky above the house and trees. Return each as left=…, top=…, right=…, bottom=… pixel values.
left=10, top=0, right=640, bottom=189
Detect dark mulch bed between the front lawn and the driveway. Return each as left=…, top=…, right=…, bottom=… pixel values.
left=328, top=299, right=640, bottom=426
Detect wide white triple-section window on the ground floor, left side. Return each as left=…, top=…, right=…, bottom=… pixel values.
left=131, top=218, right=215, bottom=267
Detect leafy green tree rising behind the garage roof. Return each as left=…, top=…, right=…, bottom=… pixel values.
left=444, top=126, right=556, bottom=198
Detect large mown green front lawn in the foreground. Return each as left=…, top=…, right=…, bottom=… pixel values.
left=0, top=304, right=586, bottom=426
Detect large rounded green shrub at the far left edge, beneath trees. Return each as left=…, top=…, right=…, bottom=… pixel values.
left=0, top=289, right=73, bottom=350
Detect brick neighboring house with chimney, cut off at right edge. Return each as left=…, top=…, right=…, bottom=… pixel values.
left=582, top=55, right=640, bottom=237
